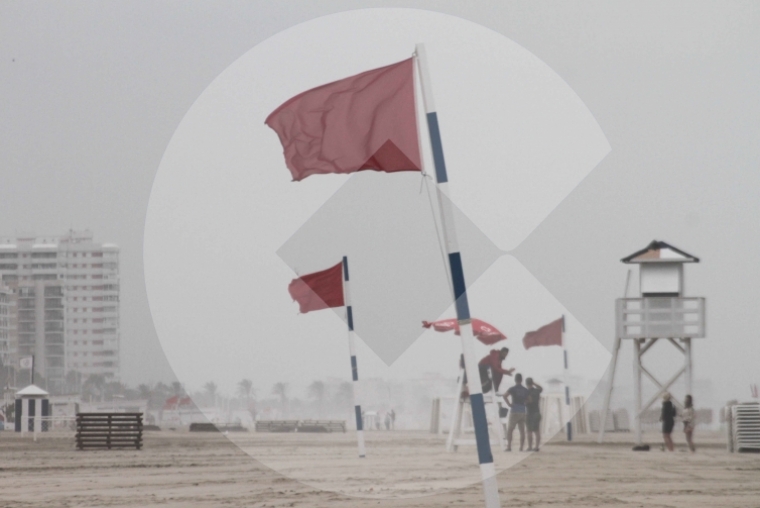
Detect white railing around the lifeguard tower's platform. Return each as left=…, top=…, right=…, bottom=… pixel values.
left=615, top=296, right=705, bottom=339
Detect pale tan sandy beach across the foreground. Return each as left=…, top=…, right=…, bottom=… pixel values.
left=0, top=431, right=760, bottom=508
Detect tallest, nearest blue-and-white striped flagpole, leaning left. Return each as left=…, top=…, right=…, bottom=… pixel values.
left=415, top=44, right=501, bottom=508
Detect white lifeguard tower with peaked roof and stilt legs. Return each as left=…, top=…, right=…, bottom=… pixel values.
left=599, top=240, right=705, bottom=450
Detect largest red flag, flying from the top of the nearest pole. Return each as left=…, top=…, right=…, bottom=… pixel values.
left=264, top=58, right=421, bottom=181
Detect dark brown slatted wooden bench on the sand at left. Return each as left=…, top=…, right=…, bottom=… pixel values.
left=76, top=413, right=143, bottom=450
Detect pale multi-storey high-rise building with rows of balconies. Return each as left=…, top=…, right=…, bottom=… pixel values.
left=0, top=231, right=120, bottom=391
